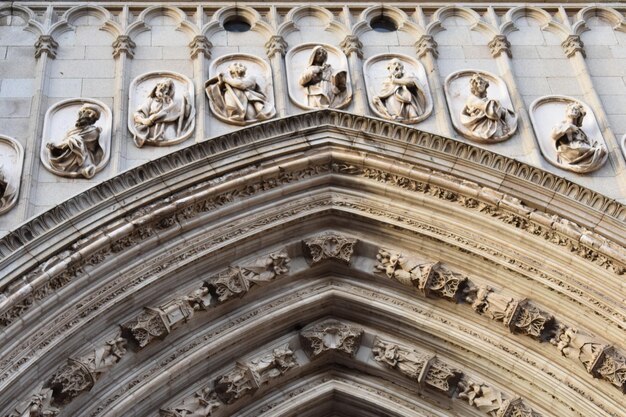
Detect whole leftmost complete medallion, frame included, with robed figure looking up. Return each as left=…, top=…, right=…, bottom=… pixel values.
left=41, top=99, right=111, bottom=178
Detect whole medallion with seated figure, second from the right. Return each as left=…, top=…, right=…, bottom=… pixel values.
left=445, top=70, right=517, bottom=143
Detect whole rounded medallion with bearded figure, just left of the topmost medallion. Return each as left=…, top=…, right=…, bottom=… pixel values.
left=205, top=54, right=276, bottom=126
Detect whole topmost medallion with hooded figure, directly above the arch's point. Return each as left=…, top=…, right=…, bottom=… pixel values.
left=285, top=43, right=352, bottom=109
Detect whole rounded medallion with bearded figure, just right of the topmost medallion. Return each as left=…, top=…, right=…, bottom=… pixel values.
left=363, top=54, right=433, bottom=123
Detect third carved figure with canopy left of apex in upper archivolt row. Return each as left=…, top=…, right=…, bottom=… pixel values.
left=47, top=337, right=126, bottom=404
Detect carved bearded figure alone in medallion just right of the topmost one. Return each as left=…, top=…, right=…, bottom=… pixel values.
left=372, top=58, right=426, bottom=122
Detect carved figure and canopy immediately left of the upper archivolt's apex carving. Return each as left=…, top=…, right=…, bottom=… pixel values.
left=206, top=251, right=290, bottom=303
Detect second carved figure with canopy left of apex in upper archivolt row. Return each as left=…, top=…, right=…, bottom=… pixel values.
left=122, top=286, right=212, bottom=349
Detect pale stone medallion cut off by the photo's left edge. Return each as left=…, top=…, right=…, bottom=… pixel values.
left=0, top=135, right=24, bottom=214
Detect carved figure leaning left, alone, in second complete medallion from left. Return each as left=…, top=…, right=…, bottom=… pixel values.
left=133, top=78, right=195, bottom=147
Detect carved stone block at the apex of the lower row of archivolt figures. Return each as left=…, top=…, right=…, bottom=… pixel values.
left=300, top=320, right=363, bottom=358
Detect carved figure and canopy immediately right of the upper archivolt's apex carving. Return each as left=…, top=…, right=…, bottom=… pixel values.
left=375, top=249, right=467, bottom=302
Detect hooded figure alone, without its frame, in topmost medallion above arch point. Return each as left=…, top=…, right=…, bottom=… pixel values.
left=299, top=45, right=348, bottom=109
